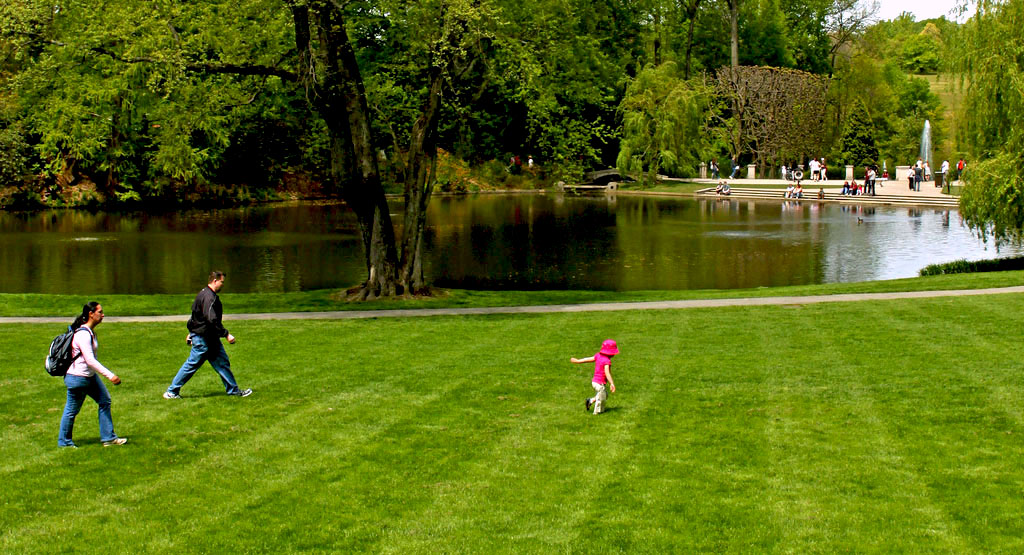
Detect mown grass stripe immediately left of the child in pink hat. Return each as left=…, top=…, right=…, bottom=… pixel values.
left=372, top=314, right=636, bottom=553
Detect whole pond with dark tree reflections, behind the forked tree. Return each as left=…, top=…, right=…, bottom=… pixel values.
left=0, top=195, right=1021, bottom=294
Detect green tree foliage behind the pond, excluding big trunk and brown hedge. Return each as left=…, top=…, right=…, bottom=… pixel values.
left=0, top=0, right=955, bottom=204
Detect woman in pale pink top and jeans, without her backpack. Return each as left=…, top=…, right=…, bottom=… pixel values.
left=57, top=301, right=128, bottom=447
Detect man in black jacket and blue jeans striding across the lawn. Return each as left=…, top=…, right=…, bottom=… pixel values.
left=164, top=270, right=253, bottom=399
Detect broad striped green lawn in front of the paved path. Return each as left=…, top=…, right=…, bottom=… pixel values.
left=0, top=295, right=1024, bottom=553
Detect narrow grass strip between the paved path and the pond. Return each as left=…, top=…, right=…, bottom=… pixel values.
left=6, top=271, right=1024, bottom=317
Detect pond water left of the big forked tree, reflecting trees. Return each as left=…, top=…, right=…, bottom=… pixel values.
left=0, top=206, right=365, bottom=294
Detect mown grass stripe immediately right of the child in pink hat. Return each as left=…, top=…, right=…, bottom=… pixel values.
left=595, top=308, right=777, bottom=552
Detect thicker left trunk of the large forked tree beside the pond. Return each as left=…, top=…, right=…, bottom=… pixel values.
left=292, top=2, right=399, bottom=299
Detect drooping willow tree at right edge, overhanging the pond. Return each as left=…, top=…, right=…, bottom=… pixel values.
left=947, top=0, right=1024, bottom=245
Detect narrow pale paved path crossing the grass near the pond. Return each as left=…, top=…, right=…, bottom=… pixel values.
left=9, top=286, right=1024, bottom=324
